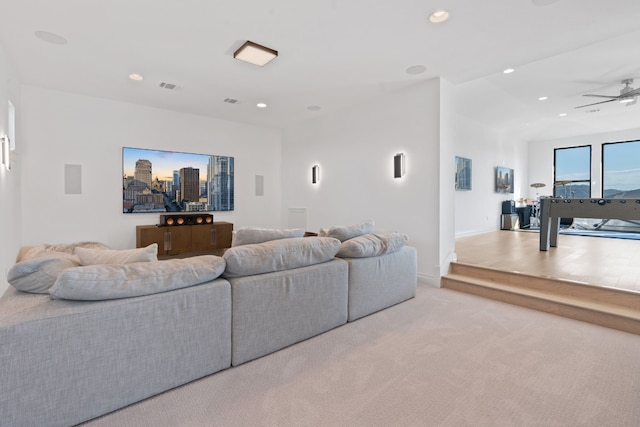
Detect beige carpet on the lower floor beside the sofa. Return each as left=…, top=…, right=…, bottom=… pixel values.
left=81, top=286, right=640, bottom=427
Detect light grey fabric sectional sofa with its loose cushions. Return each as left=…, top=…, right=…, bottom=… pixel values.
left=0, top=224, right=416, bottom=427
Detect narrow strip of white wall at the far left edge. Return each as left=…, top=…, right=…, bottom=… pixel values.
left=0, top=47, right=22, bottom=295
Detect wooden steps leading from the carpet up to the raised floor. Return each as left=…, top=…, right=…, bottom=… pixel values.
left=442, top=263, right=640, bottom=335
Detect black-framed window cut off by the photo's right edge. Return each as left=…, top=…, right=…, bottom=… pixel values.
left=602, top=141, right=640, bottom=198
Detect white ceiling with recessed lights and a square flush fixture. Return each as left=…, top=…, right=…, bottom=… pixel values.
left=0, top=0, right=640, bottom=140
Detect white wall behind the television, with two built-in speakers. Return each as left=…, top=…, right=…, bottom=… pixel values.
left=22, top=86, right=282, bottom=249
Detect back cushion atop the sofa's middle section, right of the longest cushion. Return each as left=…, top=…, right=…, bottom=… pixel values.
left=223, top=237, right=340, bottom=277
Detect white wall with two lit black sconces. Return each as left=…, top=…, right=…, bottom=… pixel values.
left=282, top=79, right=453, bottom=283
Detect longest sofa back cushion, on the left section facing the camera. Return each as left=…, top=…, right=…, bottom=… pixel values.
left=49, top=255, right=225, bottom=301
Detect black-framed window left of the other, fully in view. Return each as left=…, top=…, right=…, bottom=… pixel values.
left=553, top=145, right=591, bottom=198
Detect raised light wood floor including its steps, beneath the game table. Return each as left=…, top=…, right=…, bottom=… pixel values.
left=442, top=231, right=640, bottom=334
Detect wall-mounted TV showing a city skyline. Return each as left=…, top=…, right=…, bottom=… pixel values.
left=122, top=147, right=234, bottom=213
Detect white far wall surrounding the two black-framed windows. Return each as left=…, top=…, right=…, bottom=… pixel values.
left=528, top=129, right=640, bottom=198
